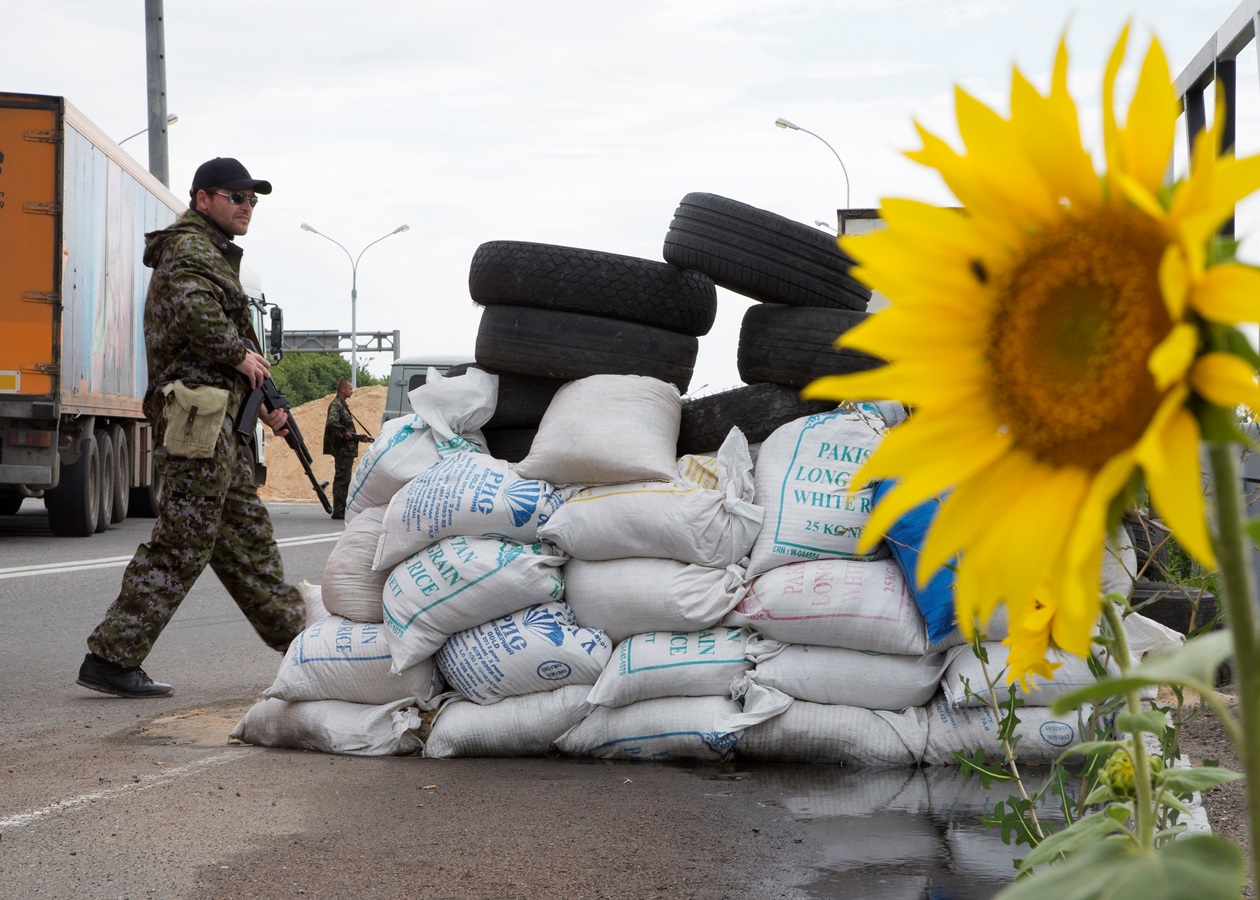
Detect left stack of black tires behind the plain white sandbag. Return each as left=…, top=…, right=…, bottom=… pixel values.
left=466, top=241, right=717, bottom=461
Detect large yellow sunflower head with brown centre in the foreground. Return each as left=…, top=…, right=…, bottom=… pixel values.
left=804, top=28, right=1260, bottom=684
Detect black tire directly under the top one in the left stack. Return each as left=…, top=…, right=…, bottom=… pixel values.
left=475, top=306, right=699, bottom=392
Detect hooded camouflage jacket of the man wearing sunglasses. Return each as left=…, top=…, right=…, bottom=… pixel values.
left=144, top=209, right=260, bottom=425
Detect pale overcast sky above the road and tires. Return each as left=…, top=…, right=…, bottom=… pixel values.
left=0, top=0, right=1260, bottom=393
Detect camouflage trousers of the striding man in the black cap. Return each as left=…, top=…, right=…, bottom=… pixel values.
left=87, top=426, right=305, bottom=667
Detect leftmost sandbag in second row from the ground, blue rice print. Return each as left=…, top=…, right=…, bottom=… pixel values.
left=262, top=615, right=441, bottom=706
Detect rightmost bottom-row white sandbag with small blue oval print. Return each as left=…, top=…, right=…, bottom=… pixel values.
left=921, top=692, right=1092, bottom=765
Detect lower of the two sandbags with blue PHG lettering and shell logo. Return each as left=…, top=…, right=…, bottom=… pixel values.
left=436, top=600, right=612, bottom=703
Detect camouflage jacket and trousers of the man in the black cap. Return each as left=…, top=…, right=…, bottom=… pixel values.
left=87, top=211, right=304, bottom=667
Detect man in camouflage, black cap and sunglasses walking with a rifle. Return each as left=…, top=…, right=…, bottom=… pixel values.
left=78, top=158, right=304, bottom=697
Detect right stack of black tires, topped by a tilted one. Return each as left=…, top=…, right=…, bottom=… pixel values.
left=664, top=193, right=881, bottom=454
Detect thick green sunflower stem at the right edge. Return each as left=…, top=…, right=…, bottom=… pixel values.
left=1207, top=441, right=1260, bottom=884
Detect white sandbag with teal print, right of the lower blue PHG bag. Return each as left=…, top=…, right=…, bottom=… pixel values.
left=587, top=625, right=752, bottom=706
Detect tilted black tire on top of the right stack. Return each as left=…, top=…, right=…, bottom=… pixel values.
left=664, top=193, right=871, bottom=310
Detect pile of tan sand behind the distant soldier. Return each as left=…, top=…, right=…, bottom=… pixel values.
left=258, top=384, right=388, bottom=503
